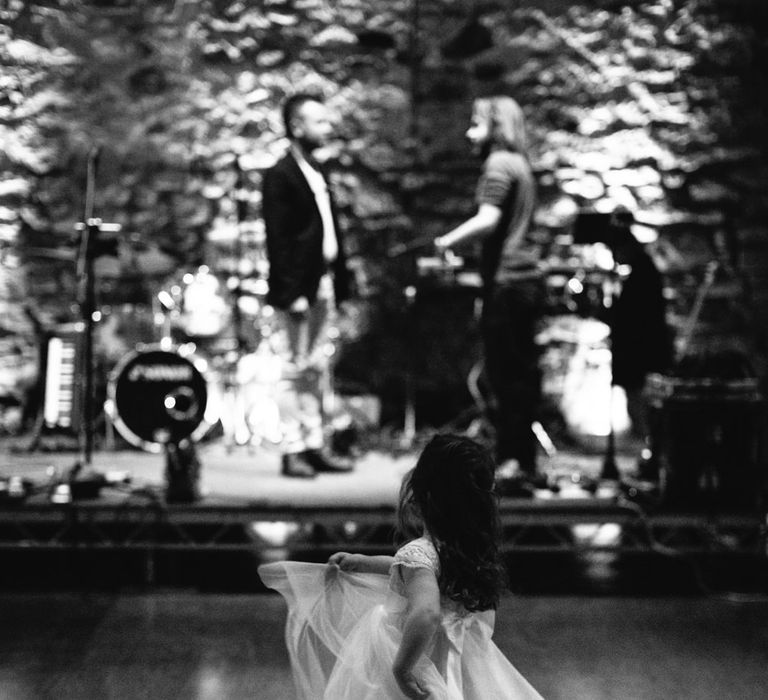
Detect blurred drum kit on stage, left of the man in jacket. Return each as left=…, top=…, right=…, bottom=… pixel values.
left=97, top=265, right=320, bottom=453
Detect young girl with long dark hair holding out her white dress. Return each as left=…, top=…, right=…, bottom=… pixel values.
left=259, top=435, right=541, bottom=700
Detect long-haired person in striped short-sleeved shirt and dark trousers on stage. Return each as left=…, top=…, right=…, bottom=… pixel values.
left=435, top=95, right=544, bottom=483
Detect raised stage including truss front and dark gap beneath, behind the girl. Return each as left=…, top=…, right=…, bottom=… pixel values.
left=0, top=441, right=768, bottom=592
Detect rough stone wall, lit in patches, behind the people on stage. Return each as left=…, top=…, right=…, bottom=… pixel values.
left=0, top=0, right=768, bottom=422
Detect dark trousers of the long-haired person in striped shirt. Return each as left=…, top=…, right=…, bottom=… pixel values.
left=482, top=278, right=544, bottom=474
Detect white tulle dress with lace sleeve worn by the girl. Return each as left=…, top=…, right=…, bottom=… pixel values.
left=259, top=537, right=541, bottom=700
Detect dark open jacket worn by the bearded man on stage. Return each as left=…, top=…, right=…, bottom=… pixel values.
left=262, top=151, right=349, bottom=309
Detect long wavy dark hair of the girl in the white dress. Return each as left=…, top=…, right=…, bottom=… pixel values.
left=398, top=435, right=506, bottom=611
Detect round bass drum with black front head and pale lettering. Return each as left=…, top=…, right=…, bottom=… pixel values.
left=105, top=347, right=211, bottom=452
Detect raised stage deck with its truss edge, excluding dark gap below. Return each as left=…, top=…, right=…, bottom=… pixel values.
left=0, top=441, right=766, bottom=583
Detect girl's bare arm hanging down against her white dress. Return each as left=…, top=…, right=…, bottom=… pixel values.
left=392, top=568, right=440, bottom=699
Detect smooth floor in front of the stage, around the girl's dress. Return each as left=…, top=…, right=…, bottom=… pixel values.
left=0, top=591, right=768, bottom=700
